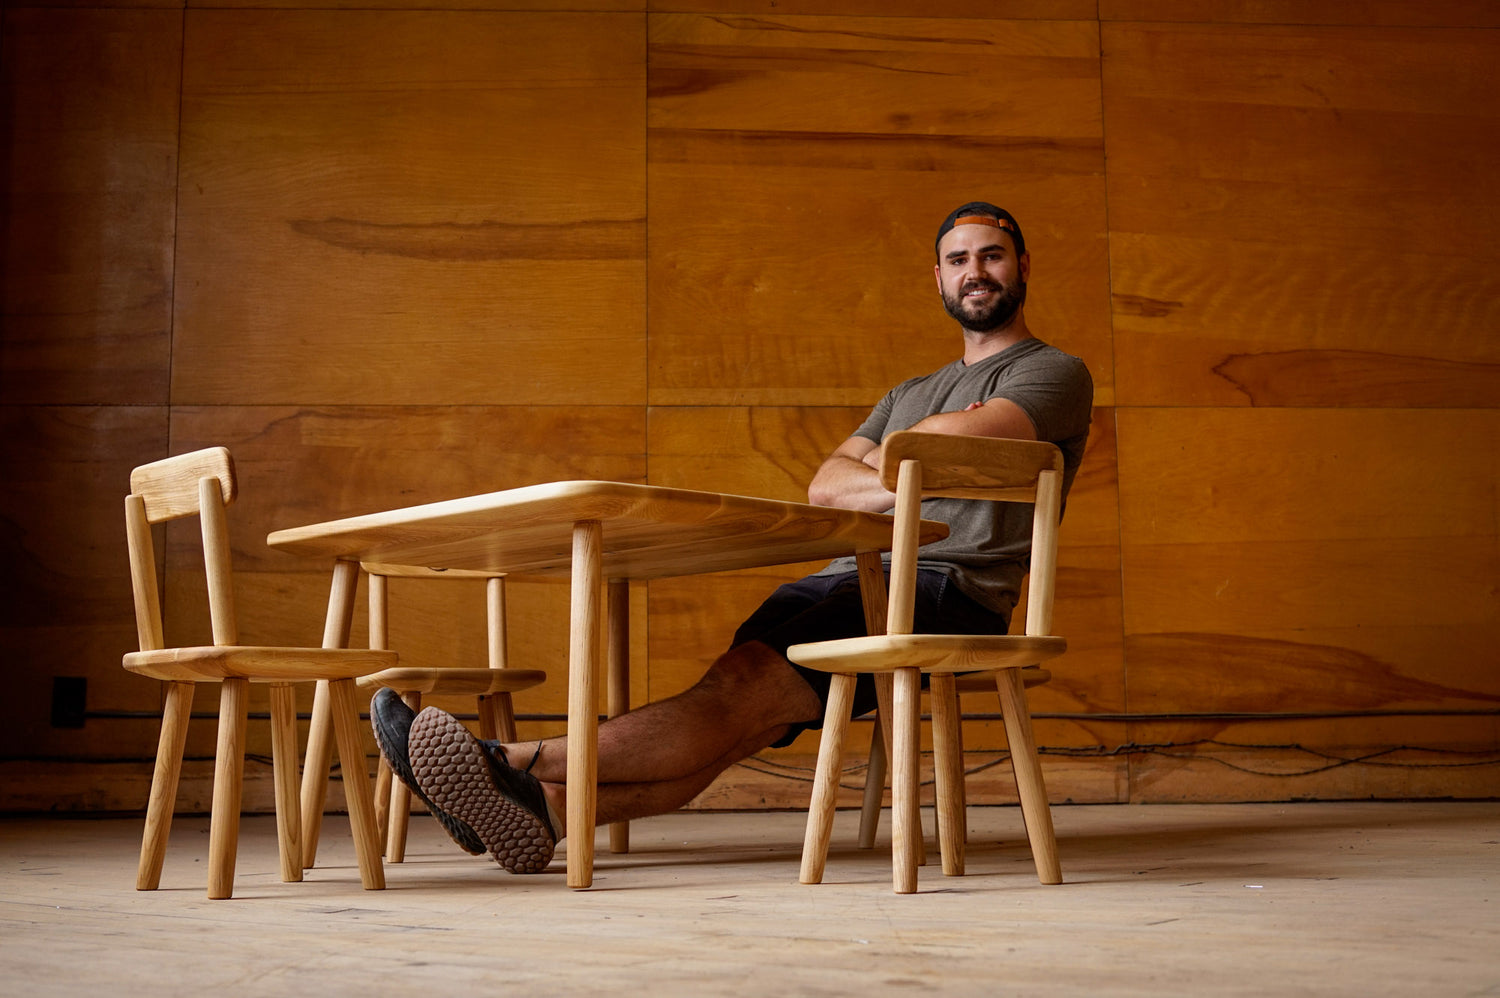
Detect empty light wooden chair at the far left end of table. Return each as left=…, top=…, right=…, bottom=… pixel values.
left=123, top=447, right=396, bottom=899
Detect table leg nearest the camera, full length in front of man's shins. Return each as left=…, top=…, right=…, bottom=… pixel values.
left=567, top=521, right=605, bottom=887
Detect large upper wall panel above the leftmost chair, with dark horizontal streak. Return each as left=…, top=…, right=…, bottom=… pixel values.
left=173, top=11, right=645, bottom=405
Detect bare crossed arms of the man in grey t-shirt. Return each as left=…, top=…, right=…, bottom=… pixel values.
left=807, top=399, right=1037, bottom=513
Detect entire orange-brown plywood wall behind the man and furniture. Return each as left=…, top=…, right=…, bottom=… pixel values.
left=0, top=0, right=1500, bottom=809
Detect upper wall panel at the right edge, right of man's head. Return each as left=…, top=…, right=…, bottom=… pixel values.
left=1103, top=24, right=1500, bottom=407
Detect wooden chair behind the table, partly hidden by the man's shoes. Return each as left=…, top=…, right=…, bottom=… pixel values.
left=359, top=563, right=548, bottom=863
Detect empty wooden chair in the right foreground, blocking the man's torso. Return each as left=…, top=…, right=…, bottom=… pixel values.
left=788, top=431, right=1068, bottom=893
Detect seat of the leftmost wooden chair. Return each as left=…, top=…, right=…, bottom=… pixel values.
left=123, top=645, right=398, bottom=683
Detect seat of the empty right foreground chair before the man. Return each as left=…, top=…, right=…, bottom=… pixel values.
left=786, top=635, right=1068, bottom=672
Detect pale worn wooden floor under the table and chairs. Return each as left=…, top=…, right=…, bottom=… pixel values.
left=0, top=803, right=1500, bottom=996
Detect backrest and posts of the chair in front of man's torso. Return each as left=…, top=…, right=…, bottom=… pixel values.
left=881, top=429, right=1062, bottom=636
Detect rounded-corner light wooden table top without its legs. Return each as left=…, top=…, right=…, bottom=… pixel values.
left=266, top=482, right=948, bottom=579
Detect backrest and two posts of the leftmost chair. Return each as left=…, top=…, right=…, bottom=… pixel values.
left=125, top=447, right=239, bottom=651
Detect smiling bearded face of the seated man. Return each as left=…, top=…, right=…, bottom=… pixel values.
left=935, top=225, right=1031, bottom=333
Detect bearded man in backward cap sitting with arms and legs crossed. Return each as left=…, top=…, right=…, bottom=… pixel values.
left=371, top=201, right=1094, bottom=873
